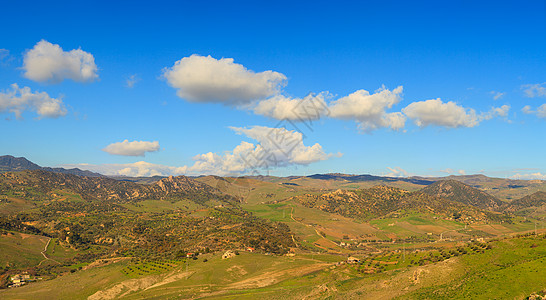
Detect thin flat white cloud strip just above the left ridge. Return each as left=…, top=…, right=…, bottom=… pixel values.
left=62, top=161, right=187, bottom=177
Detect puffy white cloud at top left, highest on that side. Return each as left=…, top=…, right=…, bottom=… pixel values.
left=23, top=40, right=99, bottom=83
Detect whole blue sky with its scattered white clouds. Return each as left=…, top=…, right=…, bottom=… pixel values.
left=0, top=1, right=546, bottom=179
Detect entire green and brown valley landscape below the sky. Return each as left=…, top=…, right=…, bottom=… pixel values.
left=0, top=159, right=546, bottom=299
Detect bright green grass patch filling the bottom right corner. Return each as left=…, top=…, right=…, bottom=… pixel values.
left=406, top=235, right=546, bottom=299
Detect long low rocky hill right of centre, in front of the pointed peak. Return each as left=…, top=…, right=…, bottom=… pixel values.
left=291, top=186, right=506, bottom=222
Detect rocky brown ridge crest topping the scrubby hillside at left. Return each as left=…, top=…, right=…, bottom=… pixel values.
left=0, top=170, right=234, bottom=204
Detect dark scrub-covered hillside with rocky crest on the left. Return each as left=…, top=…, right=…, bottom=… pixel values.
left=0, top=170, right=295, bottom=274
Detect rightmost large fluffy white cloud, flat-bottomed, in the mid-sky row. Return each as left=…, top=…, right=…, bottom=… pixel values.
left=402, top=98, right=479, bottom=128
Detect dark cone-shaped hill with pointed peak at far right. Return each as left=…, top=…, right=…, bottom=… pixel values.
left=421, top=179, right=504, bottom=211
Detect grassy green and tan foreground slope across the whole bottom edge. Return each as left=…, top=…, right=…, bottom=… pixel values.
left=0, top=234, right=546, bottom=299
